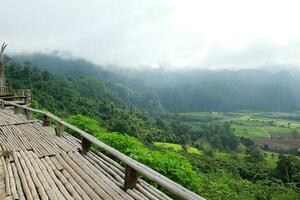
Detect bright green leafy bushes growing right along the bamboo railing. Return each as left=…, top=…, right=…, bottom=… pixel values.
left=66, top=115, right=199, bottom=195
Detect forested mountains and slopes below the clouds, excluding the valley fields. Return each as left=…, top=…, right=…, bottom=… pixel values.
left=6, top=54, right=300, bottom=199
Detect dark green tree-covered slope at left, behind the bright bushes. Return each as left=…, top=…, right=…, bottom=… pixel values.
left=6, top=63, right=164, bottom=142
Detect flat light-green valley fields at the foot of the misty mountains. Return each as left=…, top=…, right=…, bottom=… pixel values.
left=179, top=112, right=300, bottom=139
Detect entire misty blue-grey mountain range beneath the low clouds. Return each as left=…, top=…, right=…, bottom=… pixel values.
left=13, top=54, right=300, bottom=112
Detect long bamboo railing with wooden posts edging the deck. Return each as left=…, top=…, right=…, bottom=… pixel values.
left=0, top=99, right=204, bottom=200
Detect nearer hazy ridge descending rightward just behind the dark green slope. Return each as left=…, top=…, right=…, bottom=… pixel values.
left=11, top=53, right=163, bottom=112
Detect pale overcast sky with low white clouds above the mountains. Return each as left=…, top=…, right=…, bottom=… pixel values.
left=0, top=0, right=300, bottom=69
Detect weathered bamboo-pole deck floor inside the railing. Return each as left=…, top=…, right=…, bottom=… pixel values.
left=0, top=109, right=171, bottom=200
